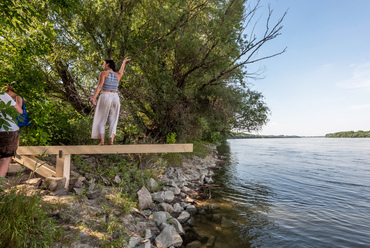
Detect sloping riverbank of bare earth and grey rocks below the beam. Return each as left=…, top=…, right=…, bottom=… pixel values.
left=6, top=144, right=222, bottom=248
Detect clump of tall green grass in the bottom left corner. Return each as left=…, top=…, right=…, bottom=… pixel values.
left=0, top=188, right=63, bottom=247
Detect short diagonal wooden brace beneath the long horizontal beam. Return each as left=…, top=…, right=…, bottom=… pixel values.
left=13, top=156, right=55, bottom=177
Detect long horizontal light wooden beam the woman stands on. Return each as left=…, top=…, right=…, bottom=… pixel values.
left=17, top=144, right=193, bottom=155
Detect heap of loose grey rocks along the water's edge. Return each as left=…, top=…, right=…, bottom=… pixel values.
left=128, top=155, right=221, bottom=248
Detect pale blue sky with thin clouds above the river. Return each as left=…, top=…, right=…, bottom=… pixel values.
left=250, top=0, right=370, bottom=136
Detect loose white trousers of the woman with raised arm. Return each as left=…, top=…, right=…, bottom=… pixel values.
left=91, top=92, right=121, bottom=139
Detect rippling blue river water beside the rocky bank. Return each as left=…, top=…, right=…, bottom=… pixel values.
left=195, top=138, right=370, bottom=248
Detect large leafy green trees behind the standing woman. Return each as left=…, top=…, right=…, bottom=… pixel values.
left=0, top=0, right=284, bottom=145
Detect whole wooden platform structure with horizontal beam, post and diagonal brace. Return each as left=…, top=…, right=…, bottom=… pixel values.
left=15, top=144, right=193, bottom=186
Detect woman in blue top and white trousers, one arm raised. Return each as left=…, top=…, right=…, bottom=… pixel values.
left=90, top=58, right=131, bottom=145
